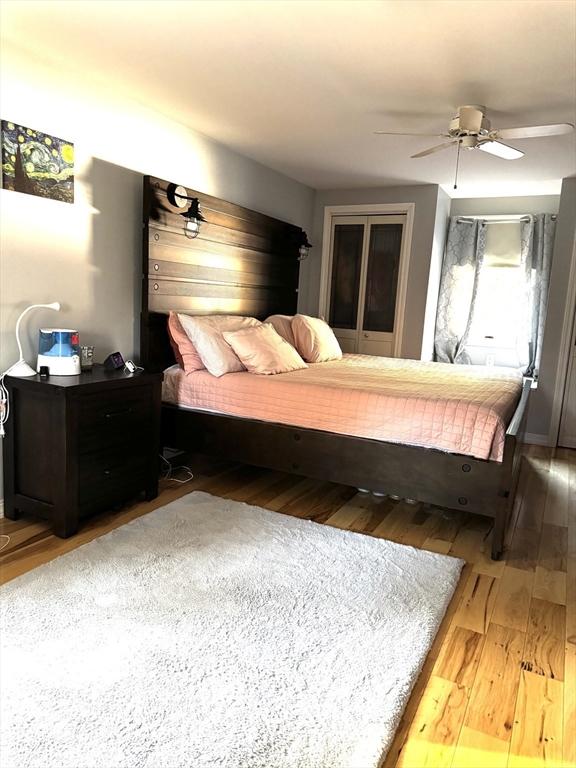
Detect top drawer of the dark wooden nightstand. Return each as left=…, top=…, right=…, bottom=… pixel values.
left=78, top=387, right=154, bottom=454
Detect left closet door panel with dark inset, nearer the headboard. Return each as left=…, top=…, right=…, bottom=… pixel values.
left=328, top=216, right=368, bottom=352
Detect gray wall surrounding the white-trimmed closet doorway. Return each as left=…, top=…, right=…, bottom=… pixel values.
left=299, top=184, right=439, bottom=359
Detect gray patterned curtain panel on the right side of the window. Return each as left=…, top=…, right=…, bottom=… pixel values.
left=520, top=213, right=556, bottom=377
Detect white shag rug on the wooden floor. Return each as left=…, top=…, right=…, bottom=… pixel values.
left=0, top=492, right=463, bottom=768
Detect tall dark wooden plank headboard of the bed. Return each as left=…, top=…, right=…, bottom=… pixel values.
left=140, top=176, right=302, bottom=371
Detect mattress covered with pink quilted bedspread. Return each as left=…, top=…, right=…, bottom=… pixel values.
left=162, top=355, right=522, bottom=461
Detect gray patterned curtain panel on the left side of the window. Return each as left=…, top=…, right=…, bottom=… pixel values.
left=434, top=216, right=486, bottom=363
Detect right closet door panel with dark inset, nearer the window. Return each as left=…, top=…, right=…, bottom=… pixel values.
left=357, top=216, right=406, bottom=357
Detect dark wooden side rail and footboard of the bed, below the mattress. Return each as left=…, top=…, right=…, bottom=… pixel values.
left=162, top=381, right=530, bottom=559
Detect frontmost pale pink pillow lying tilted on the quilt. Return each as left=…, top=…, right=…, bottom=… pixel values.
left=222, top=323, right=307, bottom=375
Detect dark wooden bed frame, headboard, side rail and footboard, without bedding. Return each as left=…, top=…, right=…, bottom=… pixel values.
left=140, top=177, right=531, bottom=560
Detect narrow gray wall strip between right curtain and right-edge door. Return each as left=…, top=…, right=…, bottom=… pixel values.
left=526, top=176, right=576, bottom=437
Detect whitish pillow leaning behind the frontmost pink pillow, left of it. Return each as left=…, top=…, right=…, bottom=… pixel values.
left=178, top=314, right=262, bottom=376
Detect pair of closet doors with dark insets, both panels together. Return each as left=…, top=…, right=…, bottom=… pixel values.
left=328, top=215, right=406, bottom=357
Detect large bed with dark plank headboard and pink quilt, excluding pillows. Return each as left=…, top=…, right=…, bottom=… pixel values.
left=141, top=177, right=531, bottom=559
